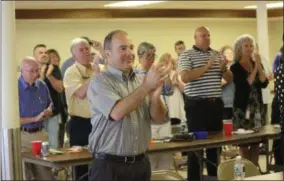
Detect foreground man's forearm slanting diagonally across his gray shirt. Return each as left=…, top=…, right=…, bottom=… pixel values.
left=110, top=84, right=150, bottom=121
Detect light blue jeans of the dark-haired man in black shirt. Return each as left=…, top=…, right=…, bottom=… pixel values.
left=44, top=114, right=61, bottom=149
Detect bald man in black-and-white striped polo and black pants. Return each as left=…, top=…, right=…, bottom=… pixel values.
left=178, top=27, right=232, bottom=180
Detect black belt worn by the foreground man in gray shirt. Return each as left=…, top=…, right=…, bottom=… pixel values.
left=94, top=153, right=146, bottom=163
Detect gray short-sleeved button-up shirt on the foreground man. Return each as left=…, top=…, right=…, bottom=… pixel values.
left=87, top=66, right=151, bottom=156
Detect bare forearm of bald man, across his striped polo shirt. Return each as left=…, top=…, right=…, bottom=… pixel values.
left=180, top=65, right=208, bottom=83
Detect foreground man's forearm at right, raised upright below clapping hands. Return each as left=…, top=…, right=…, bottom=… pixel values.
left=150, top=97, right=167, bottom=123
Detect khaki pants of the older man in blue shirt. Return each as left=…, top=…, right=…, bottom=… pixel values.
left=21, top=130, right=53, bottom=180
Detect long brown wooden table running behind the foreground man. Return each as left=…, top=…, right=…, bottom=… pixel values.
left=22, top=125, right=280, bottom=180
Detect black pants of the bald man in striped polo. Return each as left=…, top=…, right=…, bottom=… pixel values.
left=185, top=97, right=224, bottom=180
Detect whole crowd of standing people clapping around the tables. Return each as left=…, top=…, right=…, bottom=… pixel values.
left=18, top=26, right=284, bottom=181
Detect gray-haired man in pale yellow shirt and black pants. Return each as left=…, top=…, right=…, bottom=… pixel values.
left=63, top=38, right=100, bottom=180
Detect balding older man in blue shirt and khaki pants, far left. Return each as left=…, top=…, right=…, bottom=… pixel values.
left=18, top=57, right=53, bottom=180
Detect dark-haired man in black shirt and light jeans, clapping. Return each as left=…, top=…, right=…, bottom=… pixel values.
left=34, top=44, right=63, bottom=149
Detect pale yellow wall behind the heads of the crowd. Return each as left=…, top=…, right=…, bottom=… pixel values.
left=16, top=18, right=283, bottom=66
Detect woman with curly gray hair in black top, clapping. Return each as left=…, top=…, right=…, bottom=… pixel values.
left=230, top=35, right=268, bottom=165
